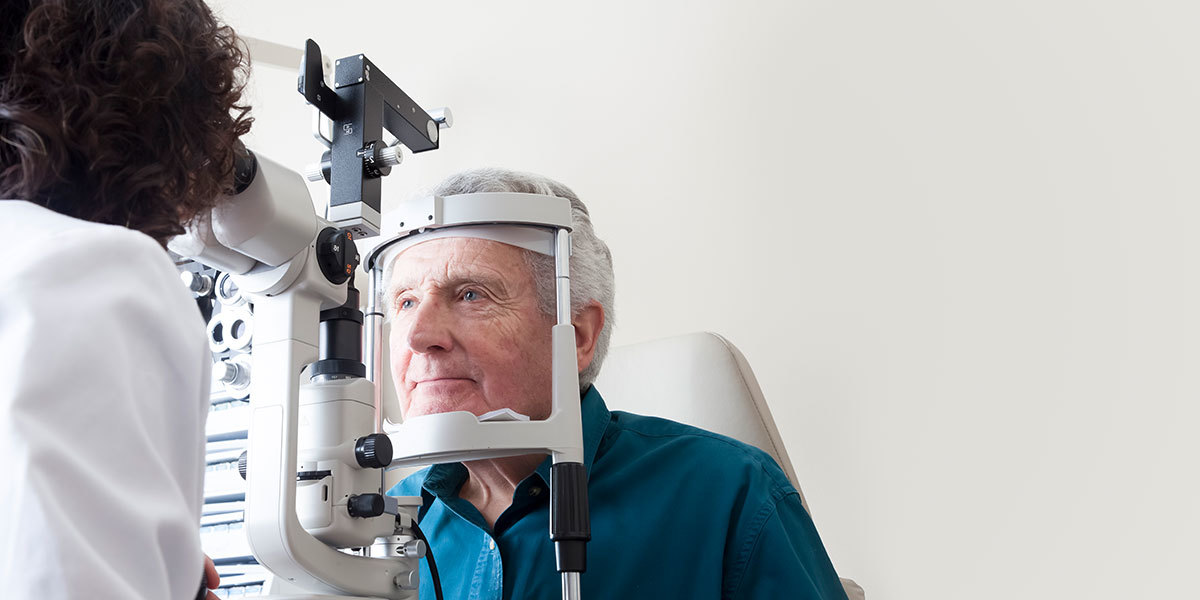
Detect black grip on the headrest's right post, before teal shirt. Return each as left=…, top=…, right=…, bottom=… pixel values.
left=550, top=462, right=592, bottom=572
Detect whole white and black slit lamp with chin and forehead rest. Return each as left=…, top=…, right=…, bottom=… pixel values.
left=168, top=40, right=590, bottom=600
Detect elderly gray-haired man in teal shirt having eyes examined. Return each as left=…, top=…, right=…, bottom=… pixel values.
left=386, top=169, right=846, bottom=600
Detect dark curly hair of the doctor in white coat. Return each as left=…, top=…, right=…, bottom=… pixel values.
left=0, top=0, right=252, bottom=244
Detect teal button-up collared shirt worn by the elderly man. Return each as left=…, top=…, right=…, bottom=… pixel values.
left=388, top=386, right=846, bottom=600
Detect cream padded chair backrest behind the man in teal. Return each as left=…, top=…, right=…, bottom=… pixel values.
left=595, top=332, right=865, bottom=600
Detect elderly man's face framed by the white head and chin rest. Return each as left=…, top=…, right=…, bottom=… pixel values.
left=386, top=238, right=553, bottom=419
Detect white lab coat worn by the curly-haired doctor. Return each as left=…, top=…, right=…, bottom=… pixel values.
left=0, top=200, right=211, bottom=600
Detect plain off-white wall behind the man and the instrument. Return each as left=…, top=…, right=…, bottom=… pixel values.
left=216, top=0, right=1200, bottom=600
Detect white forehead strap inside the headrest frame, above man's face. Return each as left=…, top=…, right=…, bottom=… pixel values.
left=378, top=226, right=554, bottom=289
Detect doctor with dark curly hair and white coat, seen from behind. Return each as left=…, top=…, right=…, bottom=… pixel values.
left=0, top=0, right=251, bottom=600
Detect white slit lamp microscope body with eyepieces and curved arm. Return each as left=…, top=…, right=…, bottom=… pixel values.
left=170, top=151, right=419, bottom=600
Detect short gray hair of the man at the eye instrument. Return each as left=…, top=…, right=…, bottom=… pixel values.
left=430, top=168, right=616, bottom=390
